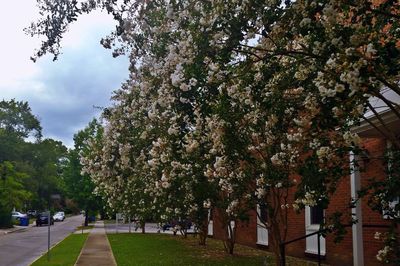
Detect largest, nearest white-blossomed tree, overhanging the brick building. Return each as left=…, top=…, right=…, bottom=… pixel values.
left=30, top=0, right=400, bottom=262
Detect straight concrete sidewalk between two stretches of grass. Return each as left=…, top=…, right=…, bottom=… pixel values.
left=75, top=221, right=117, bottom=266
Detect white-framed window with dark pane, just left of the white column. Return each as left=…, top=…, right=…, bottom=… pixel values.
left=305, top=206, right=326, bottom=256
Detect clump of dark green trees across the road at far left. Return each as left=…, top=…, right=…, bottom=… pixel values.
left=0, top=100, right=66, bottom=225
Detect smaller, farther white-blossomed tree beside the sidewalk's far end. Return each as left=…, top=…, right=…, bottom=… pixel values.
left=82, top=85, right=153, bottom=232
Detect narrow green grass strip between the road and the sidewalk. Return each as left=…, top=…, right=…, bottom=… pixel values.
left=32, top=234, right=88, bottom=266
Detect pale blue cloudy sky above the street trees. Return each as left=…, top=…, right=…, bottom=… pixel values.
left=0, top=0, right=128, bottom=147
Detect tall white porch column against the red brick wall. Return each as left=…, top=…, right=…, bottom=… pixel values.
left=350, top=152, right=364, bottom=266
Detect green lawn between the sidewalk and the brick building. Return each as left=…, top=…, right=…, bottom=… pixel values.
left=108, top=234, right=271, bottom=266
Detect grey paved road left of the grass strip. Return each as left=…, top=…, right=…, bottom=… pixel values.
left=0, top=215, right=84, bottom=266
